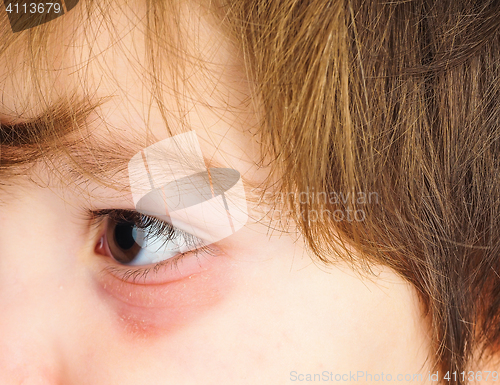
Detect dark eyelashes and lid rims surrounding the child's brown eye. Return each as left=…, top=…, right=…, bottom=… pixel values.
left=88, top=209, right=215, bottom=283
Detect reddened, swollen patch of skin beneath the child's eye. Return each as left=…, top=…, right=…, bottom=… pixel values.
left=91, top=257, right=235, bottom=340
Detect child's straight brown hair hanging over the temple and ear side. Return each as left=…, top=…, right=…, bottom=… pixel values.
left=0, top=0, right=500, bottom=384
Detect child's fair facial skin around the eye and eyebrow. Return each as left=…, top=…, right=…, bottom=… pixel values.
left=0, top=4, right=427, bottom=385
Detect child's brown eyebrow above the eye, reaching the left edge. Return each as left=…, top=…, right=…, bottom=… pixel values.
left=0, top=96, right=253, bottom=189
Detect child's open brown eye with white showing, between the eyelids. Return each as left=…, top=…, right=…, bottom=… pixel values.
left=94, top=210, right=203, bottom=266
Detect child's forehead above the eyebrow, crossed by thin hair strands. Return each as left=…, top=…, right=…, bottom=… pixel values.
left=0, top=1, right=258, bottom=176
